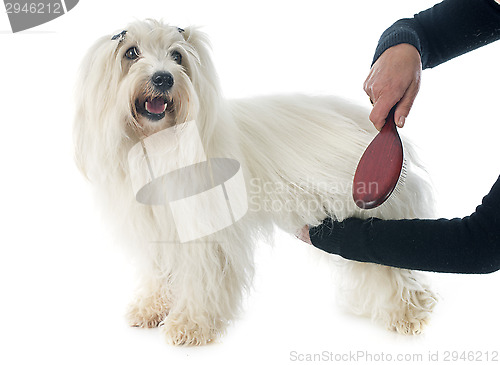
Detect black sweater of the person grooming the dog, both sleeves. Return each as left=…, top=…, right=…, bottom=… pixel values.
left=309, top=0, right=500, bottom=273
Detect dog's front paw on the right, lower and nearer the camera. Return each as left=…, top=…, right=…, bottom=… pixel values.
left=161, top=314, right=221, bottom=346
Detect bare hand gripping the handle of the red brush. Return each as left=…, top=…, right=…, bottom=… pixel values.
left=363, top=43, right=422, bottom=130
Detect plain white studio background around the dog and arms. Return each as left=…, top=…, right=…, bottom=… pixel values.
left=0, top=0, right=500, bottom=364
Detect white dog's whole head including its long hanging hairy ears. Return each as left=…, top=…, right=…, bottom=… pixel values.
left=74, top=20, right=219, bottom=181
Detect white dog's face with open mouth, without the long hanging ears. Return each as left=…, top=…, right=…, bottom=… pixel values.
left=109, top=21, right=200, bottom=135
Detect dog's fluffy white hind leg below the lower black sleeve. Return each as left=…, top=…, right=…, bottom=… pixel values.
left=340, top=261, right=437, bottom=334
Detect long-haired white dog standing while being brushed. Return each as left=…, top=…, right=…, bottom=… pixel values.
left=74, top=20, right=436, bottom=345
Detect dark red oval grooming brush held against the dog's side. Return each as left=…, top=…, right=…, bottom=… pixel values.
left=352, top=107, right=406, bottom=209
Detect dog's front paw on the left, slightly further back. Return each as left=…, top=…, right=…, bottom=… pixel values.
left=126, top=296, right=168, bottom=328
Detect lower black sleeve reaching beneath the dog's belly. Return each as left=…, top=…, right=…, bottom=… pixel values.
left=309, top=177, right=500, bottom=274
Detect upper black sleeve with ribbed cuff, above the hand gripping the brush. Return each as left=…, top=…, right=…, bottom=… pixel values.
left=372, top=0, right=500, bottom=69
